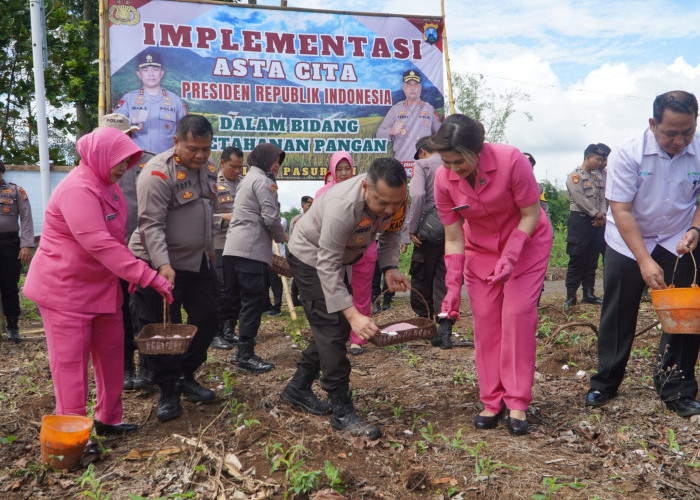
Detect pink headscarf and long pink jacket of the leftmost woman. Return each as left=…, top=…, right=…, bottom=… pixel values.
left=24, top=128, right=156, bottom=314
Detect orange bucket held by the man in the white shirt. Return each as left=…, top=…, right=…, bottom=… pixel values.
left=651, top=284, right=700, bottom=334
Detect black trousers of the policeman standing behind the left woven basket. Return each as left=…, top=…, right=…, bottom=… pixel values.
left=130, top=255, right=218, bottom=385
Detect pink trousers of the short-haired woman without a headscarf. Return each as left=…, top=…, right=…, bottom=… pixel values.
left=464, top=255, right=549, bottom=413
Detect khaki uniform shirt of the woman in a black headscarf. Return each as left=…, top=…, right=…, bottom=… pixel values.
left=224, top=167, right=285, bottom=265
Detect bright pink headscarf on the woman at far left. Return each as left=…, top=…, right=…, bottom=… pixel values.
left=75, top=127, right=143, bottom=184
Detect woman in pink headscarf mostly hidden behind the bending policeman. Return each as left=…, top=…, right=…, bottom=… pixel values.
left=316, top=152, right=377, bottom=356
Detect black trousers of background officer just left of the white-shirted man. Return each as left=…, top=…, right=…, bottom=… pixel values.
left=565, top=212, right=605, bottom=289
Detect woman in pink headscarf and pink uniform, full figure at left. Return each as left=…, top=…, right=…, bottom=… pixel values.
left=23, top=128, right=173, bottom=434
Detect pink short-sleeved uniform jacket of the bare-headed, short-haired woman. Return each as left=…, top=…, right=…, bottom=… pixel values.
left=435, top=143, right=552, bottom=280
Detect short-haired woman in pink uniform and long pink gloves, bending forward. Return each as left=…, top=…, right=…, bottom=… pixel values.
left=431, top=114, right=552, bottom=435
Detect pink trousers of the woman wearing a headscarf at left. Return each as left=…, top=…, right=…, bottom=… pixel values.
left=39, top=306, right=124, bottom=425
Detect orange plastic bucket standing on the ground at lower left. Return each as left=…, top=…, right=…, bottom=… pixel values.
left=39, top=415, right=92, bottom=469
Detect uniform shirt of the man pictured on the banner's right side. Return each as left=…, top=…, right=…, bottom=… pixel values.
left=377, top=101, right=440, bottom=162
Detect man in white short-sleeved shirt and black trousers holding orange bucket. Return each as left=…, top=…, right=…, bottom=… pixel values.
left=585, top=91, right=700, bottom=417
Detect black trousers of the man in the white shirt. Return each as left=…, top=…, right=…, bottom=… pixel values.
left=591, top=246, right=700, bottom=401
